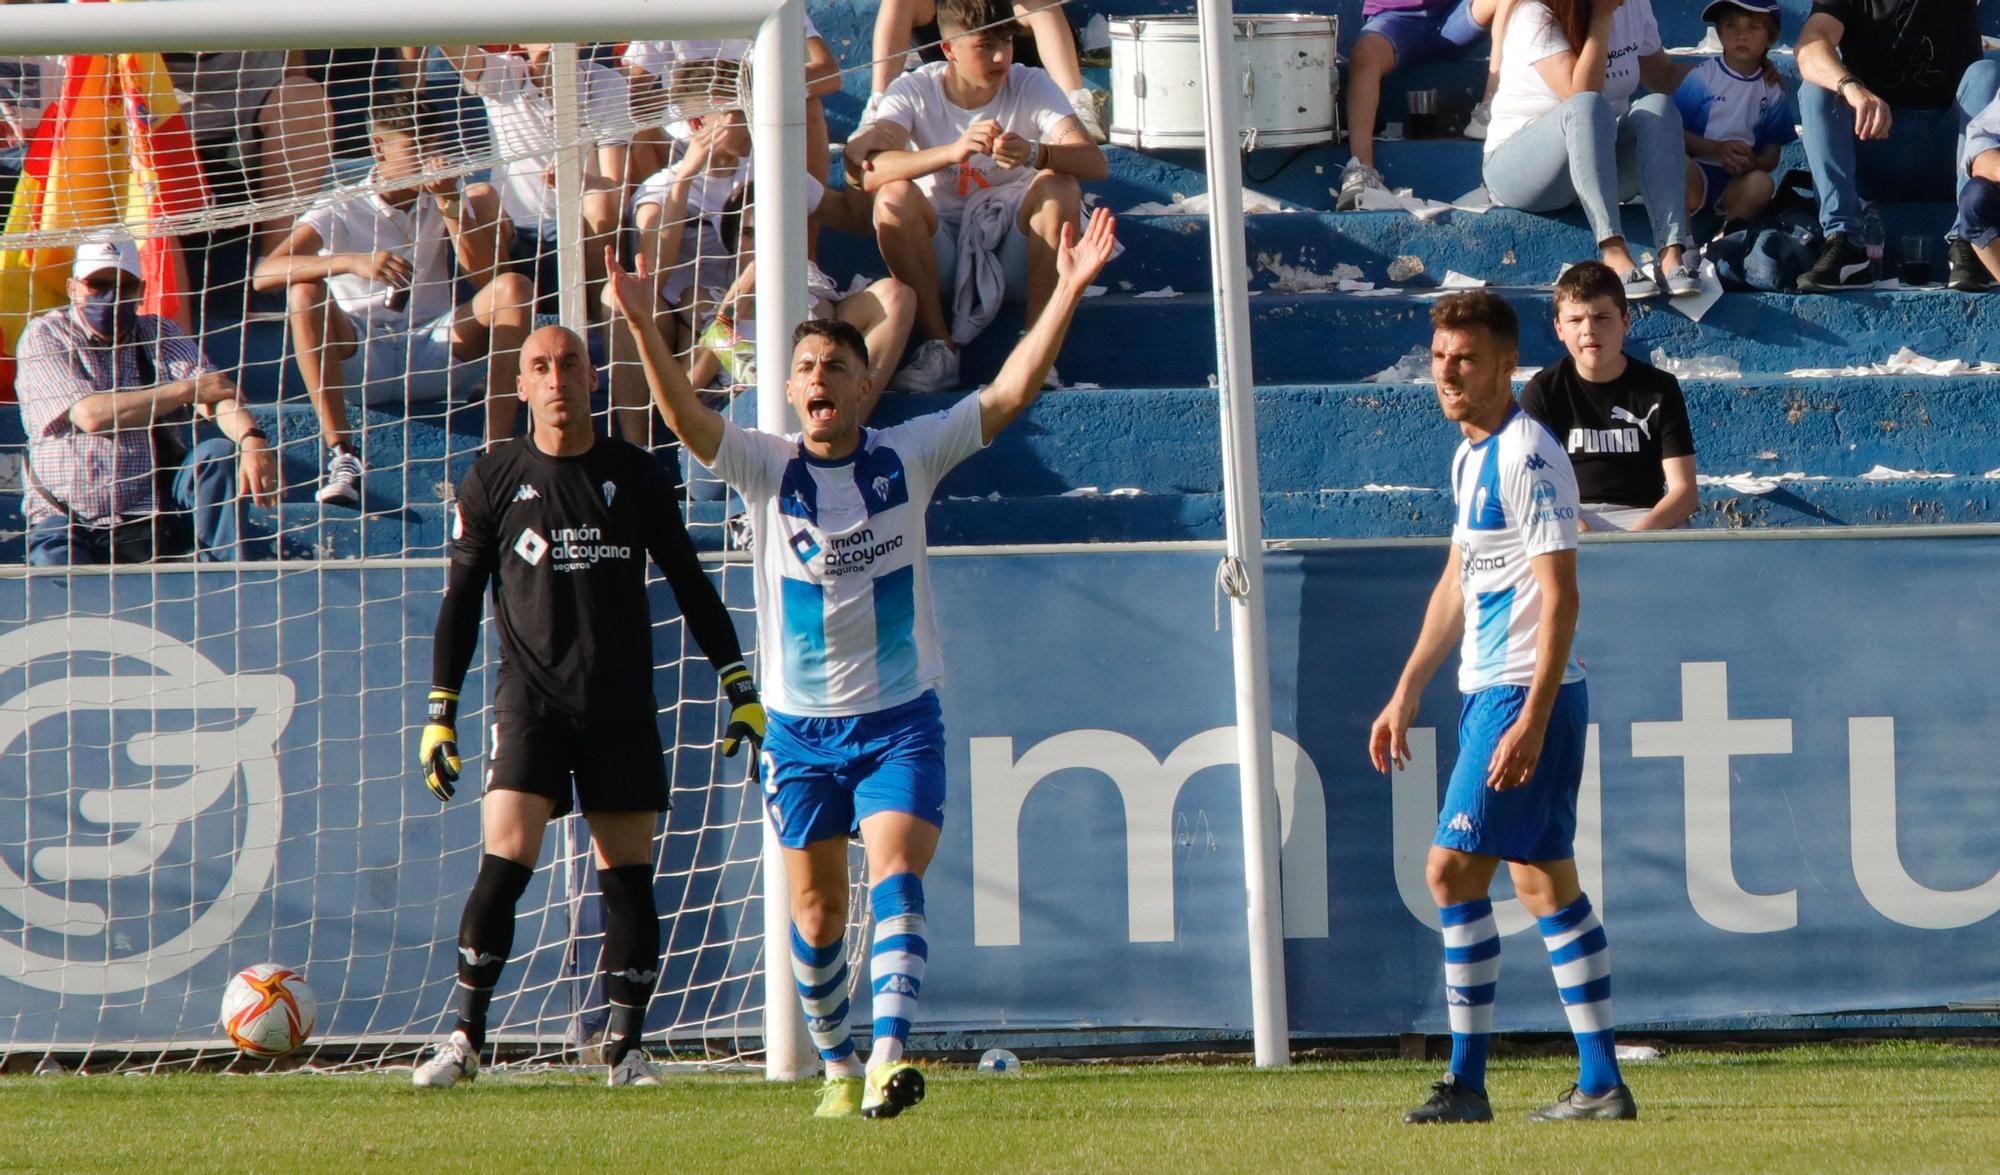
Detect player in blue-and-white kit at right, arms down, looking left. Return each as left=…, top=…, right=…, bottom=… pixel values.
left=1368, top=290, right=1638, bottom=1123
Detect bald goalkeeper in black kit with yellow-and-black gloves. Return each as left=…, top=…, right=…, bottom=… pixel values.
left=414, top=326, right=764, bottom=1087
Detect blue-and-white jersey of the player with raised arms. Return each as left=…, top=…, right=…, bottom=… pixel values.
left=714, top=394, right=986, bottom=717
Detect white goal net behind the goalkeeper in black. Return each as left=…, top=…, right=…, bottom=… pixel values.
left=0, top=0, right=836, bottom=1069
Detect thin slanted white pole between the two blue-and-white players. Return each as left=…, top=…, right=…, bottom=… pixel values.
left=1196, top=0, right=1292, bottom=1067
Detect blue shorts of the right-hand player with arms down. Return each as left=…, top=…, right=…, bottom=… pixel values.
left=1432, top=681, right=1590, bottom=861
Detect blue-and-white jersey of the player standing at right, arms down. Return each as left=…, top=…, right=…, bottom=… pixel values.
left=1452, top=408, right=1584, bottom=693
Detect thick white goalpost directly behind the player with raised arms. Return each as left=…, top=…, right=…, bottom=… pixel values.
left=750, top=0, right=818, bottom=1081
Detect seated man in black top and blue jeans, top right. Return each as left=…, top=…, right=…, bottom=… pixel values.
left=1798, top=0, right=2000, bottom=292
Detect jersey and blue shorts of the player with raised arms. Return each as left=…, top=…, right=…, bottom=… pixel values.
left=712, top=396, right=984, bottom=847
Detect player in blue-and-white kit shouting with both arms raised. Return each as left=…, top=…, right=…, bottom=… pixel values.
left=606, top=210, right=1116, bottom=1117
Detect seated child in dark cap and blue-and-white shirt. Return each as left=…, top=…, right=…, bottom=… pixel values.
left=1674, top=0, right=1798, bottom=232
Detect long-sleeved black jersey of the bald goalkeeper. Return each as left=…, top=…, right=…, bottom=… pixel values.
left=432, top=436, right=742, bottom=723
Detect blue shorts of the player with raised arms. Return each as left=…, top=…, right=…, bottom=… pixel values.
left=764, top=689, right=944, bottom=849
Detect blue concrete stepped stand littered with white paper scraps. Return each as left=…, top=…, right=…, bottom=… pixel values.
left=0, top=0, right=2000, bottom=564
